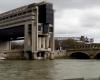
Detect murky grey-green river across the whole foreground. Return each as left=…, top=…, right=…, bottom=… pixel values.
left=0, top=59, right=100, bottom=80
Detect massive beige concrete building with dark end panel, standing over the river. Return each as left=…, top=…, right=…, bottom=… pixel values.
left=0, top=2, right=54, bottom=59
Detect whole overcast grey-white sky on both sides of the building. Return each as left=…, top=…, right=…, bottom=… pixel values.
left=0, top=0, right=100, bottom=42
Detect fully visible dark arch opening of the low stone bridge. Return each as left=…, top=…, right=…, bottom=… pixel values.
left=70, top=52, right=90, bottom=59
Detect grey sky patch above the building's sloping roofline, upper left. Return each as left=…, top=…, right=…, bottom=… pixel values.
left=0, top=0, right=38, bottom=11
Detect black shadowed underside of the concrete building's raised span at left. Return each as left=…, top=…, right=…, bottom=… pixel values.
left=0, top=25, right=24, bottom=40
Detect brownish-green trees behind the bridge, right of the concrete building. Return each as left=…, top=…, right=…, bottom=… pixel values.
left=55, top=36, right=93, bottom=50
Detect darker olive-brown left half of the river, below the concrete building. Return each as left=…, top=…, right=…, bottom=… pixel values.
left=0, top=60, right=54, bottom=80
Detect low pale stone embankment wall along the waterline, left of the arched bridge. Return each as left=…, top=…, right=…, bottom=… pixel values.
left=0, top=50, right=67, bottom=60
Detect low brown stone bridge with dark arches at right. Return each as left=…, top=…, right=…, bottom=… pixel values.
left=66, top=44, right=100, bottom=59
